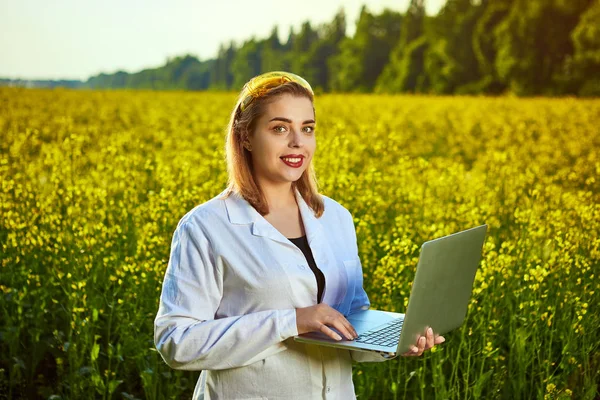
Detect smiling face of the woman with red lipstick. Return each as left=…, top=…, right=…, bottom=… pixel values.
left=249, top=93, right=317, bottom=188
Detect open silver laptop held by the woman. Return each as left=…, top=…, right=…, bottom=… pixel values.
left=294, top=224, right=488, bottom=359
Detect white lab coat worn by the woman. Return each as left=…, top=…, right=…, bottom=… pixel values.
left=154, top=190, right=386, bottom=400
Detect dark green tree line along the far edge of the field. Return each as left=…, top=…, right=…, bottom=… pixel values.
left=22, top=0, right=600, bottom=96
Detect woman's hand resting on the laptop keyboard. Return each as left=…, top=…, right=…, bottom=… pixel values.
left=296, top=303, right=358, bottom=340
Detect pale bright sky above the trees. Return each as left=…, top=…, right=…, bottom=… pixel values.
left=0, top=0, right=445, bottom=80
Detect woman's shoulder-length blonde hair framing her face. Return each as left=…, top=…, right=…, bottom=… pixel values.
left=221, top=82, right=325, bottom=218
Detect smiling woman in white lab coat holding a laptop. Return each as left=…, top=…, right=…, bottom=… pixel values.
left=154, top=72, right=444, bottom=400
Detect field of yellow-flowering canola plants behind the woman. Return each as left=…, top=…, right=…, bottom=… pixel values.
left=0, top=88, right=600, bottom=400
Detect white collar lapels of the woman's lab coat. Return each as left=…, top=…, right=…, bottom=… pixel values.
left=225, top=188, right=323, bottom=244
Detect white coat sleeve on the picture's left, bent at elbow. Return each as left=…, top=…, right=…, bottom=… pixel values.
left=154, top=217, right=298, bottom=371
